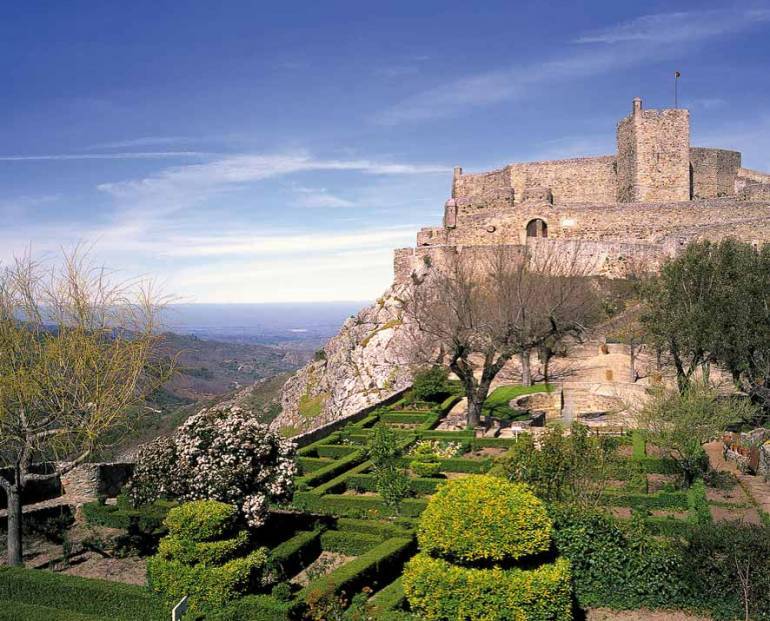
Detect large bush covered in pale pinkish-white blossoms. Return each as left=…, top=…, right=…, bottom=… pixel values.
left=129, top=406, right=297, bottom=528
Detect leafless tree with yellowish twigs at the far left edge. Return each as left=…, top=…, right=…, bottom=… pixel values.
left=0, top=250, right=173, bottom=565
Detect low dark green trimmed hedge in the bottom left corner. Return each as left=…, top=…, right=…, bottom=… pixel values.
left=0, top=567, right=170, bottom=621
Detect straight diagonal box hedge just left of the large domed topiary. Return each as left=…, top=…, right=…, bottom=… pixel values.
left=298, top=537, right=414, bottom=599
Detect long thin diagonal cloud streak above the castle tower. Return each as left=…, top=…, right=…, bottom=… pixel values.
left=375, top=9, right=770, bottom=125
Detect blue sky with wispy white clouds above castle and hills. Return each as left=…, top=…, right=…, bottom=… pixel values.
left=0, top=0, right=770, bottom=302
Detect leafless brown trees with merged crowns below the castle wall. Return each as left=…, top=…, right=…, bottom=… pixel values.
left=404, top=244, right=597, bottom=426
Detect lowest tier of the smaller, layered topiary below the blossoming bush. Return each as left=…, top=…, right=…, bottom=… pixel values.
left=147, top=548, right=268, bottom=610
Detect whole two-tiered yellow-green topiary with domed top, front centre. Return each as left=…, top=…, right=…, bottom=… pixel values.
left=403, top=475, right=572, bottom=621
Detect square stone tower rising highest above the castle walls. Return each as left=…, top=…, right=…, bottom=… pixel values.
left=617, top=97, right=691, bottom=203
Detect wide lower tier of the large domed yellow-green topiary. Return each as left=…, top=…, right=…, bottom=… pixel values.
left=403, top=552, right=572, bottom=621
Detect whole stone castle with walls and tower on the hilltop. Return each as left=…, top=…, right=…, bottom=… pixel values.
left=394, top=97, right=770, bottom=283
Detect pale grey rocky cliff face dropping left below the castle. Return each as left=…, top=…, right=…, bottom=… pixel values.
left=271, top=285, right=412, bottom=435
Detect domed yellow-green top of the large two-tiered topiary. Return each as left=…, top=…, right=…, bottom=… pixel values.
left=417, top=475, right=553, bottom=563
